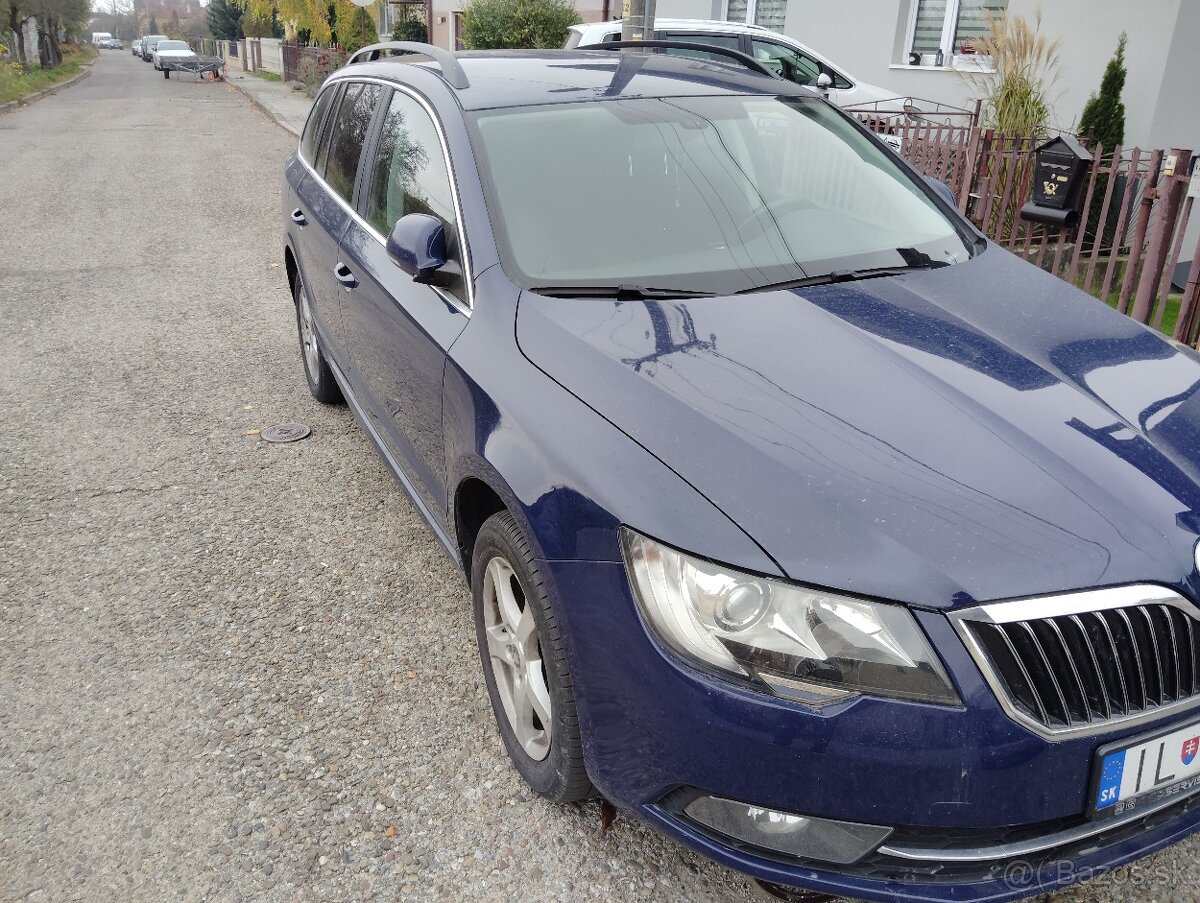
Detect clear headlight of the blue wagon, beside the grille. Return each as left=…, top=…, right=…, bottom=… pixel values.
left=622, top=527, right=959, bottom=705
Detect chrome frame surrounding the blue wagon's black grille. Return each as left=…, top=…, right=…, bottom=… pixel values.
left=947, top=585, right=1200, bottom=741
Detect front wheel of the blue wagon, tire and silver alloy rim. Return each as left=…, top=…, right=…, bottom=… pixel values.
left=470, top=512, right=593, bottom=802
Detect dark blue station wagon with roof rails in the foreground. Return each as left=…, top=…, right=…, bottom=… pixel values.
left=282, top=44, right=1200, bottom=903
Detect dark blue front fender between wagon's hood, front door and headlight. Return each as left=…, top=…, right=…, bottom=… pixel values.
left=443, top=267, right=780, bottom=575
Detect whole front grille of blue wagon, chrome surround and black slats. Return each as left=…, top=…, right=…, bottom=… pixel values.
left=952, top=586, right=1200, bottom=735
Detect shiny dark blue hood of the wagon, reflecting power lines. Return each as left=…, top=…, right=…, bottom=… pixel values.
left=517, top=247, right=1200, bottom=606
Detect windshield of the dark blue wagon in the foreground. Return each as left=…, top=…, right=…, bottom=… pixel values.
left=473, top=96, right=973, bottom=294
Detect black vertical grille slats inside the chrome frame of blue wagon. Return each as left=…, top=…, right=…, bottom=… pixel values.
left=964, top=603, right=1200, bottom=731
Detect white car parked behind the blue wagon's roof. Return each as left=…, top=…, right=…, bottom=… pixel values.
left=565, top=19, right=907, bottom=112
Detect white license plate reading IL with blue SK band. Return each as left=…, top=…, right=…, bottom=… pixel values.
left=1092, top=720, right=1200, bottom=818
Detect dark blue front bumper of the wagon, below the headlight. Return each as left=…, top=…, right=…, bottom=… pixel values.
left=542, top=562, right=1200, bottom=901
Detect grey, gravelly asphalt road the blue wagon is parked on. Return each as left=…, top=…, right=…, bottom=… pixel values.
left=0, top=47, right=1200, bottom=901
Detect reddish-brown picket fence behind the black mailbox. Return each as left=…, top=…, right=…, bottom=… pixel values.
left=852, top=109, right=1200, bottom=346
